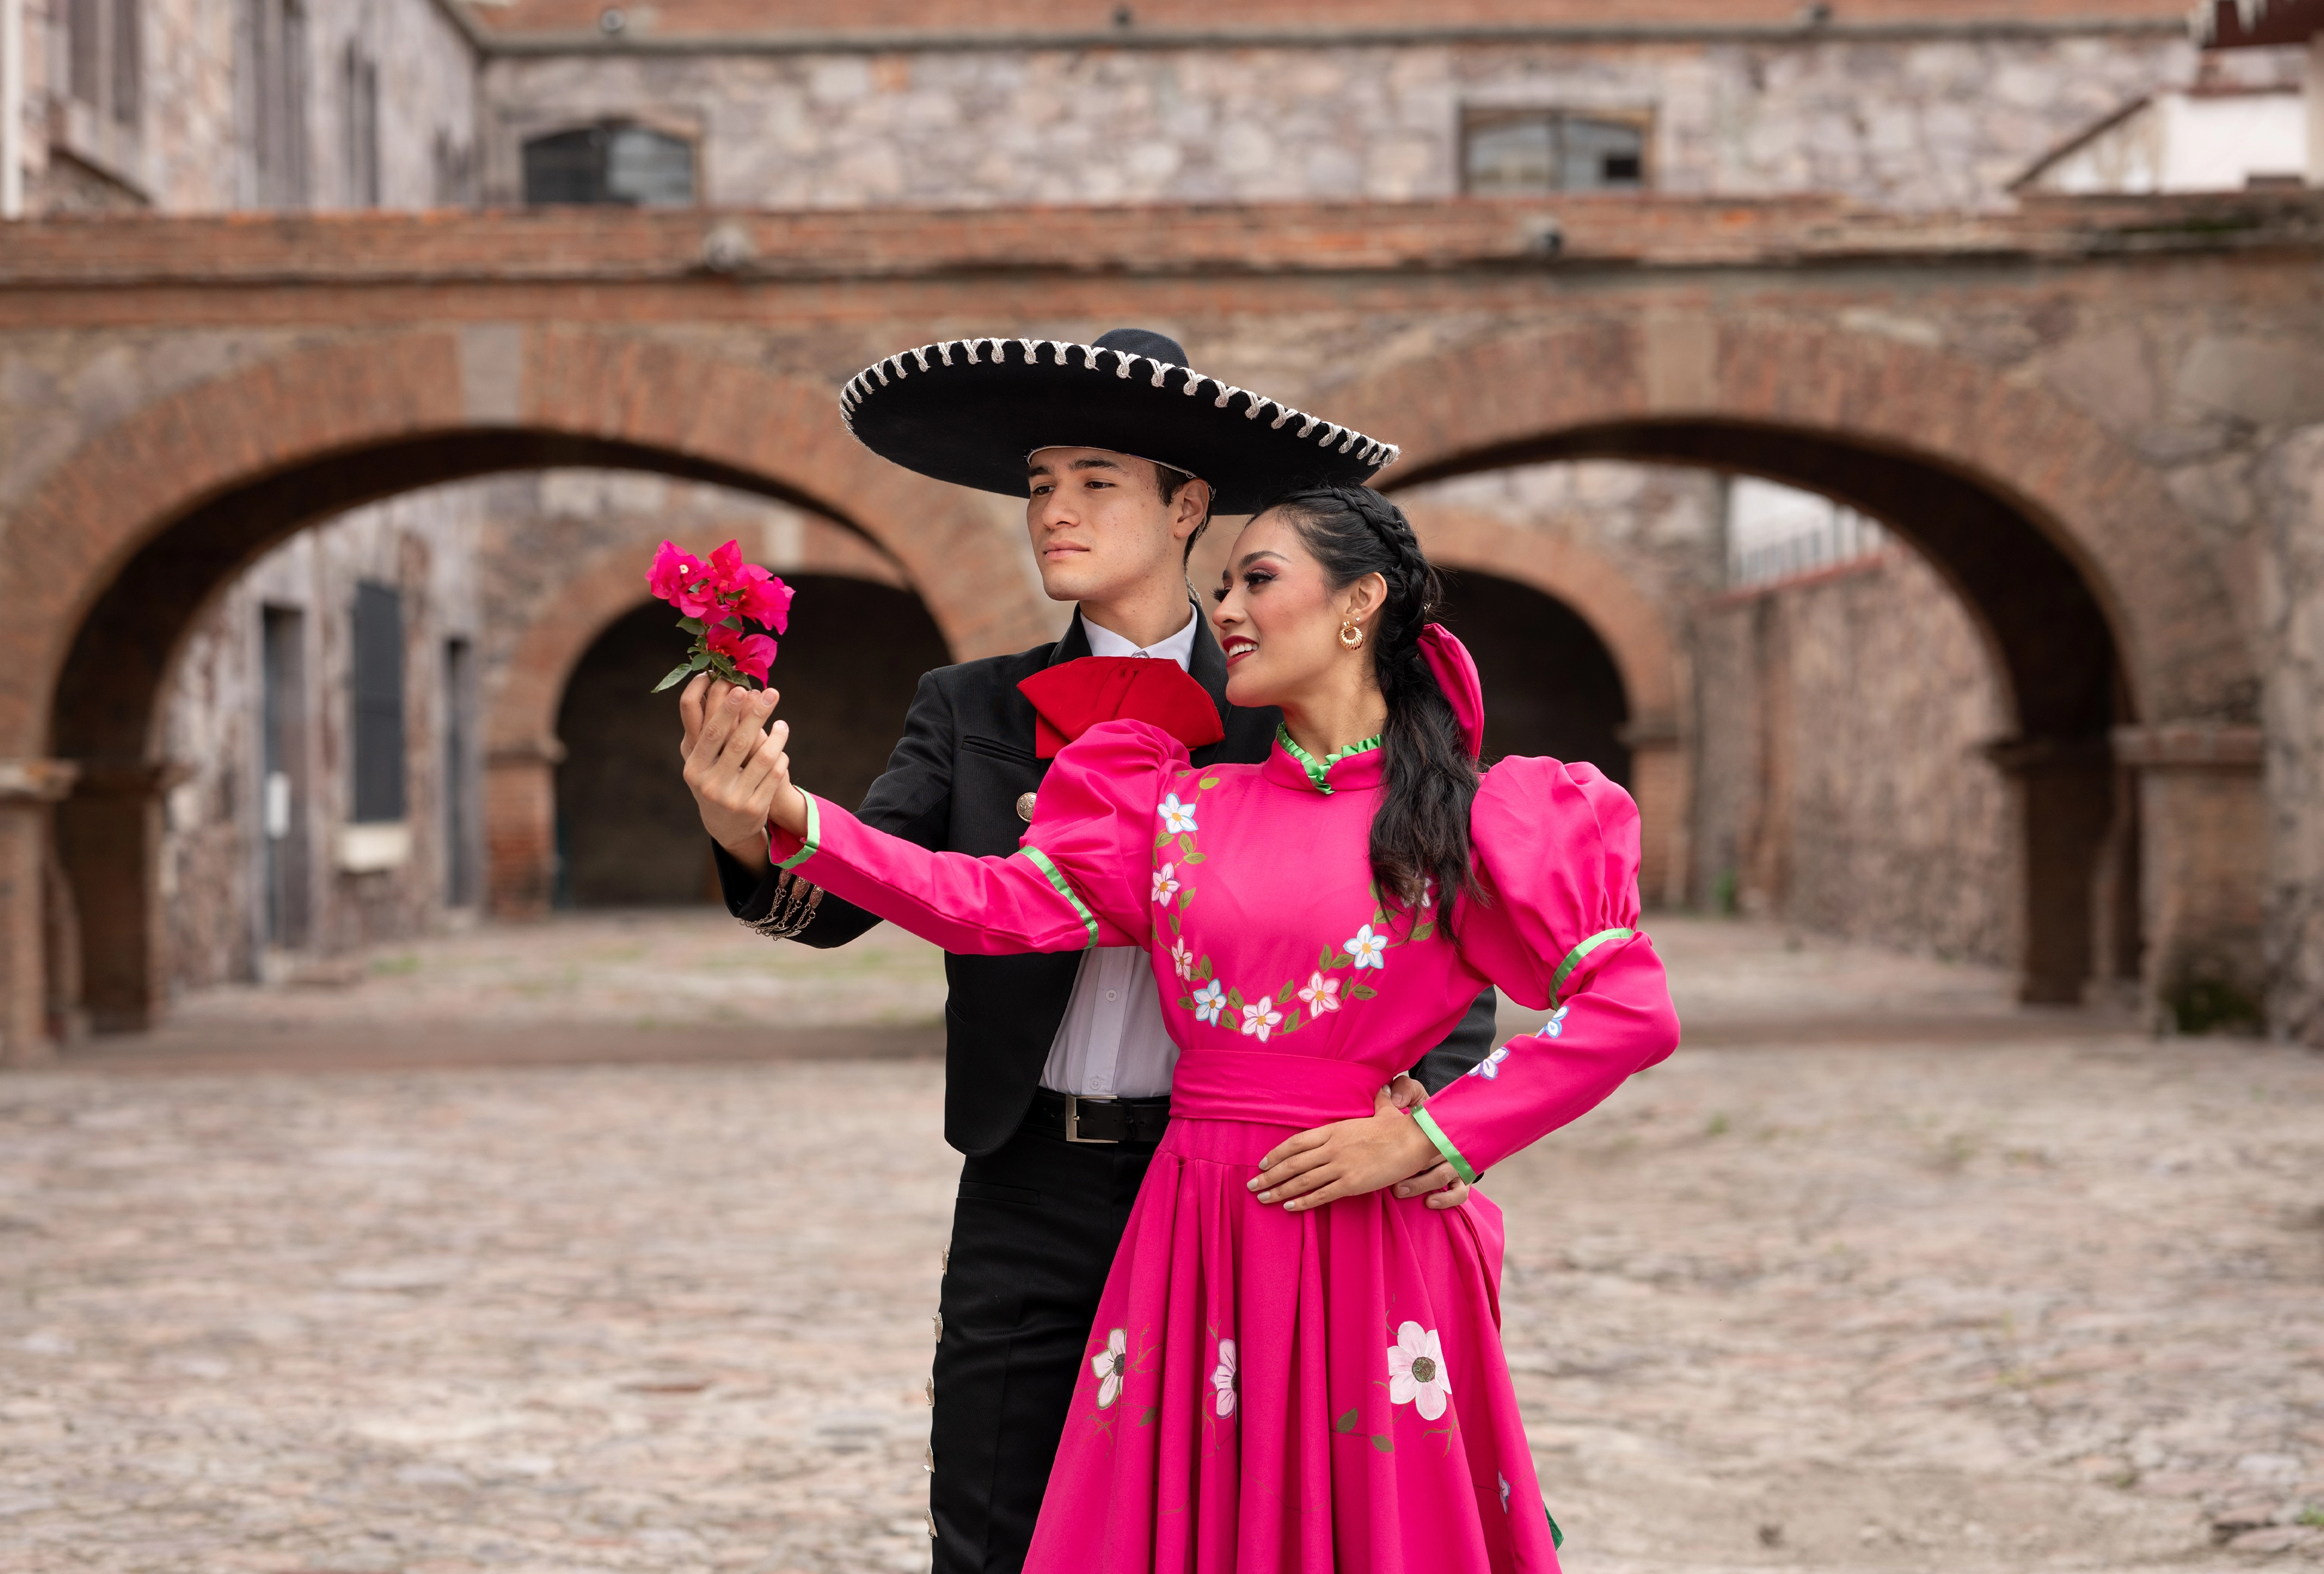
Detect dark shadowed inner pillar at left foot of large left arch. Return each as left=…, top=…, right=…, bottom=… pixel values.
left=56, top=760, right=183, bottom=1032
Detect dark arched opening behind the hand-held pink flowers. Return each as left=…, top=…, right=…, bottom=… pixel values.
left=558, top=575, right=951, bottom=907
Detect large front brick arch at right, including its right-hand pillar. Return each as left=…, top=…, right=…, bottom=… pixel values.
left=1331, top=323, right=2263, bottom=999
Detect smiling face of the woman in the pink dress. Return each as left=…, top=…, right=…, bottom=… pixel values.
left=1211, top=509, right=1376, bottom=709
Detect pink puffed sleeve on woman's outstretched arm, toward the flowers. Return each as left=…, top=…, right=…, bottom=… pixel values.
left=769, top=721, right=1187, bottom=955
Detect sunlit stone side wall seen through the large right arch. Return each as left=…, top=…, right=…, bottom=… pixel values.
left=1694, top=551, right=2022, bottom=963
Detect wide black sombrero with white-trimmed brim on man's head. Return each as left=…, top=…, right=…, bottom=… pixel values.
left=839, top=328, right=1397, bottom=514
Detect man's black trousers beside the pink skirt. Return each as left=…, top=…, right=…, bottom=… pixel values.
left=927, top=1130, right=1155, bottom=1574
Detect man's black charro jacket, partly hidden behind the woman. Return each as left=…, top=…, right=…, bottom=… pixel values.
left=718, top=611, right=1497, bottom=1156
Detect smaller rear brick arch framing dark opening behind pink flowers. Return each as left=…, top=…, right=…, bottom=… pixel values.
left=484, top=516, right=916, bottom=918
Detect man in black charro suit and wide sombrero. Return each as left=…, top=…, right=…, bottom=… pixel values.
left=681, top=328, right=1494, bottom=1574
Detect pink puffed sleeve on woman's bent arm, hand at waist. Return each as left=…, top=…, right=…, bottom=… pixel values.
left=1416, top=758, right=1678, bottom=1179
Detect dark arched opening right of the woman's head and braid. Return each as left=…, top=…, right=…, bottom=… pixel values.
left=1441, top=572, right=1629, bottom=786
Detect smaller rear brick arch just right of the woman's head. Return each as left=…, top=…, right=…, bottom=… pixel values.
left=1406, top=502, right=1694, bottom=904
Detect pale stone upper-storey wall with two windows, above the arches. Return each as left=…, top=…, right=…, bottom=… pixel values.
left=484, top=30, right=2196, bottom=209
